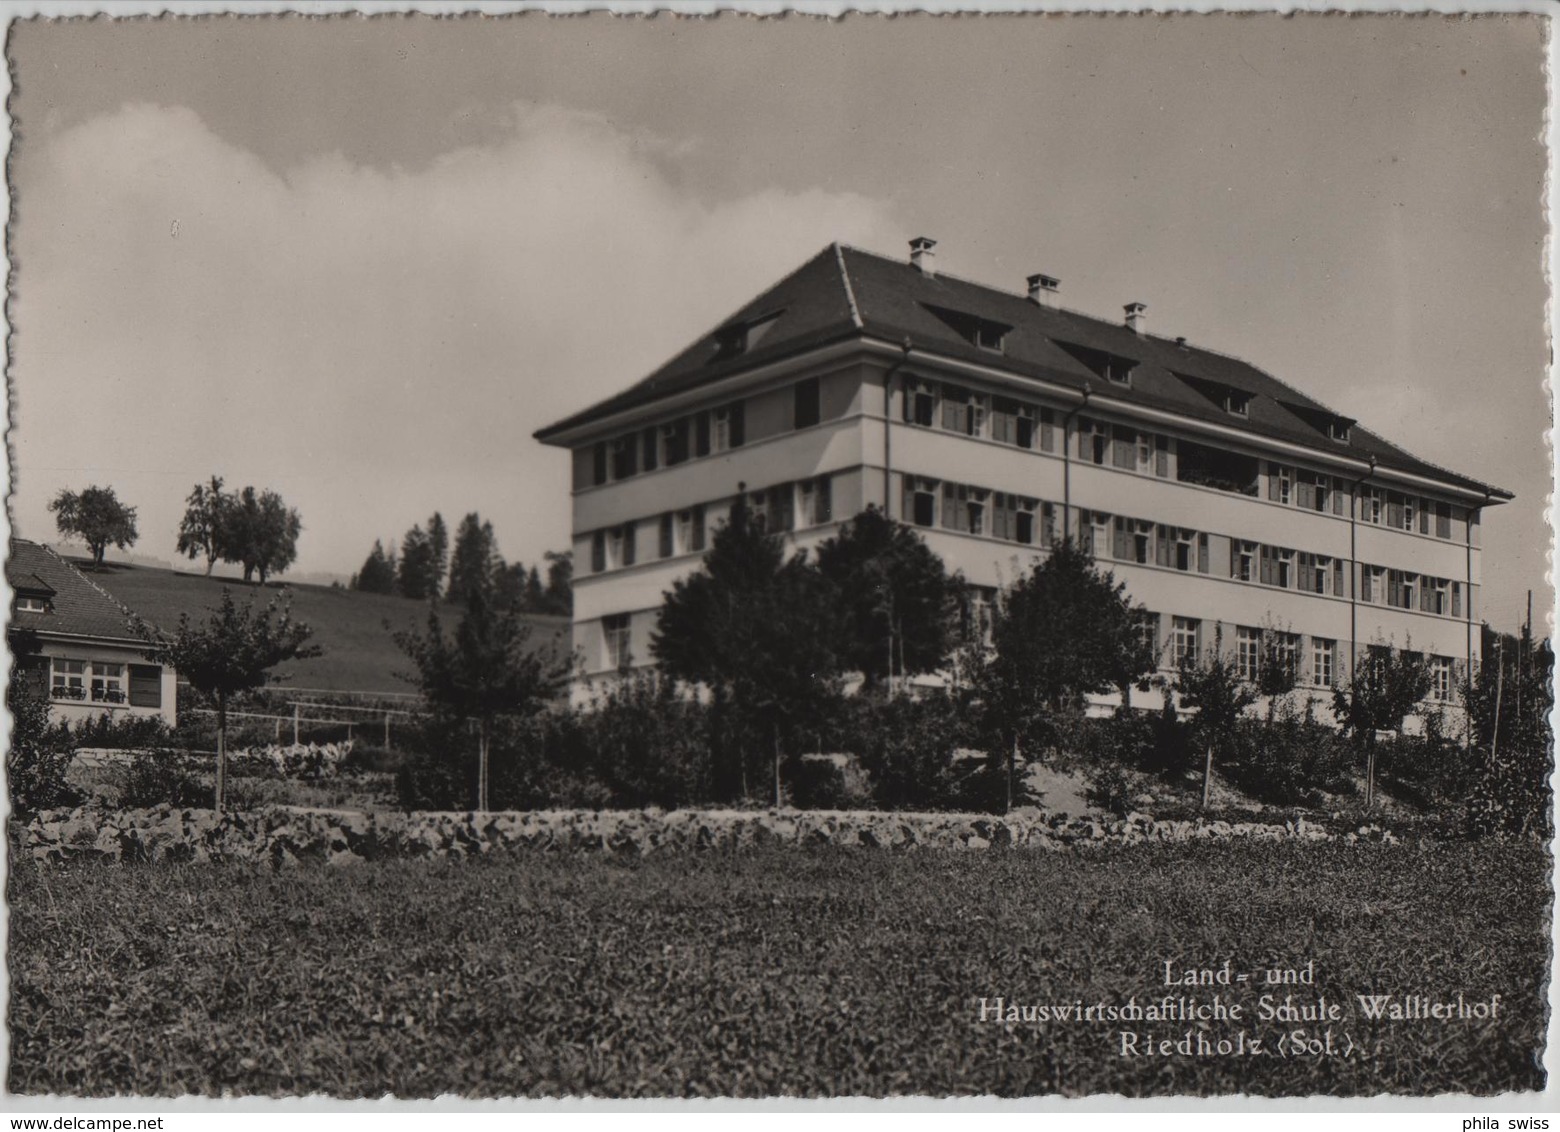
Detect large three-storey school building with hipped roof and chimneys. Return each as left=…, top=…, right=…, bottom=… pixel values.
left=537, top=239, right=1512, bottom=717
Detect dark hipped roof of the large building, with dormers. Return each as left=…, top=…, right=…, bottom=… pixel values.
left=535, top=245, right=1512, bottom=499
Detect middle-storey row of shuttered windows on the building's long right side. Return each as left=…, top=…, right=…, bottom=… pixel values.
left=903, top=476, right=1462, bottom=617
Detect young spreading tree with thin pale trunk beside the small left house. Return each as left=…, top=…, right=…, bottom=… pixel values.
left=133, top=586, right=320, bottom=811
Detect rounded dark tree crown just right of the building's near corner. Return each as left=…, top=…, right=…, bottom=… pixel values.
left=817, top=507, right=959, bottom=685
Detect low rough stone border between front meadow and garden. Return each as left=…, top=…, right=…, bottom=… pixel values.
left=22, top=806, right=1395, bottom=865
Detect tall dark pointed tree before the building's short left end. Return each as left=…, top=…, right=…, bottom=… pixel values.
left=651, top=496, right=838, bottom=805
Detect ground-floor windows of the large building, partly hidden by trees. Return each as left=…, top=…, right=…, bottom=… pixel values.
left=601, top=608, right=1457, bottom=703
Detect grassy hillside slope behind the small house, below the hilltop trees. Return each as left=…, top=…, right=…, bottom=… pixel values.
left=76, top=561, right=568, bottom=692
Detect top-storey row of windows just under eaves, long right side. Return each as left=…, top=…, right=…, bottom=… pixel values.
left=905, top=382, right=1452, bottom=539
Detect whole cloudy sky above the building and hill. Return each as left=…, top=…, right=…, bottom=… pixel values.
left=8, top=12, right=1552, bottom=639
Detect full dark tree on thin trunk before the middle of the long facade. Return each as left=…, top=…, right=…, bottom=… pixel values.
left=975, top=539, right=1156, bottom=806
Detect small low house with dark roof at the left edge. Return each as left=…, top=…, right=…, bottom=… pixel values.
left=5, top=538, right=178, bottom=727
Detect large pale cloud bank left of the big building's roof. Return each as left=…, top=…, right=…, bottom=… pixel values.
left=12, top=104, right=900, bottom=571
